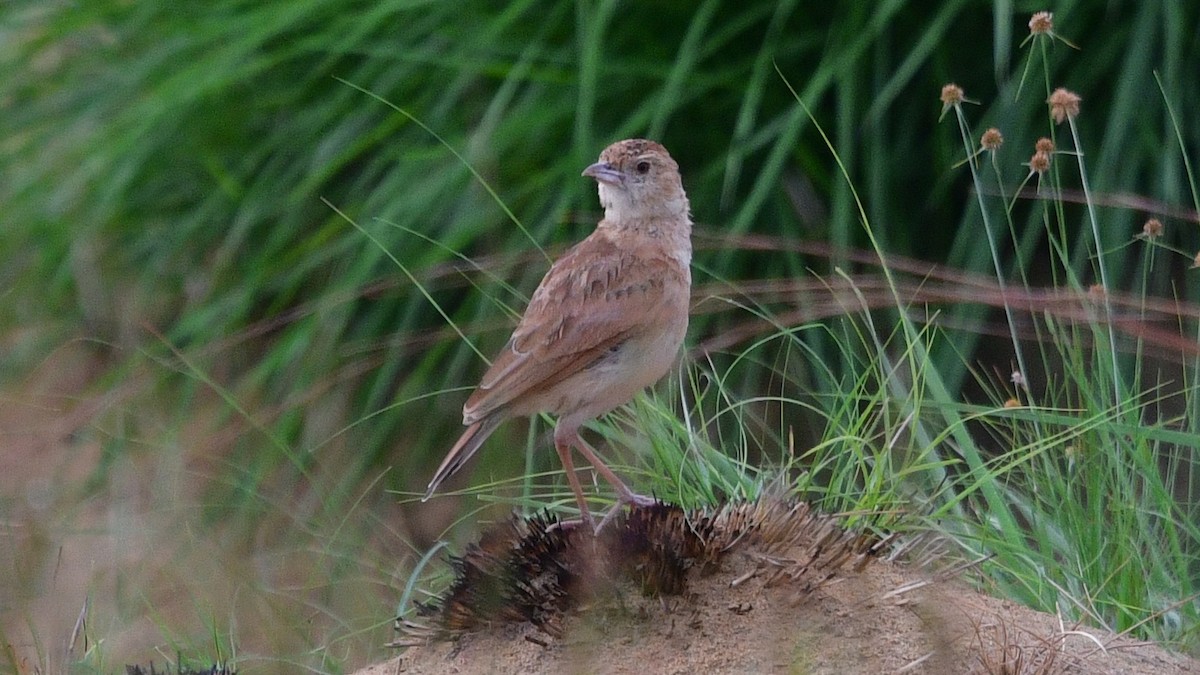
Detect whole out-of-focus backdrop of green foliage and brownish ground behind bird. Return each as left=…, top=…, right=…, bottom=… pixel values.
left=0, top=0, right=1200, bottom=673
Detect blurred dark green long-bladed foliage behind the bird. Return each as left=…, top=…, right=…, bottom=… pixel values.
left=0, top=0, right=1200, bottom=662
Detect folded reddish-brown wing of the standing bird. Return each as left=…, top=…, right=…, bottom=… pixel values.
left=463, top=231, right=680, bottom=424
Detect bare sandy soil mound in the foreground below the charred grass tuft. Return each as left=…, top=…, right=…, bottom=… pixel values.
left=358, top=554, right=1200, bottom=675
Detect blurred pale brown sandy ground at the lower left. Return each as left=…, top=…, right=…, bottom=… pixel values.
left=0, top=341, right=405, bottom=675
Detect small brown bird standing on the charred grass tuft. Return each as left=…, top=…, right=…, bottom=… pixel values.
left=425, top=139, right=691, bottom=527
